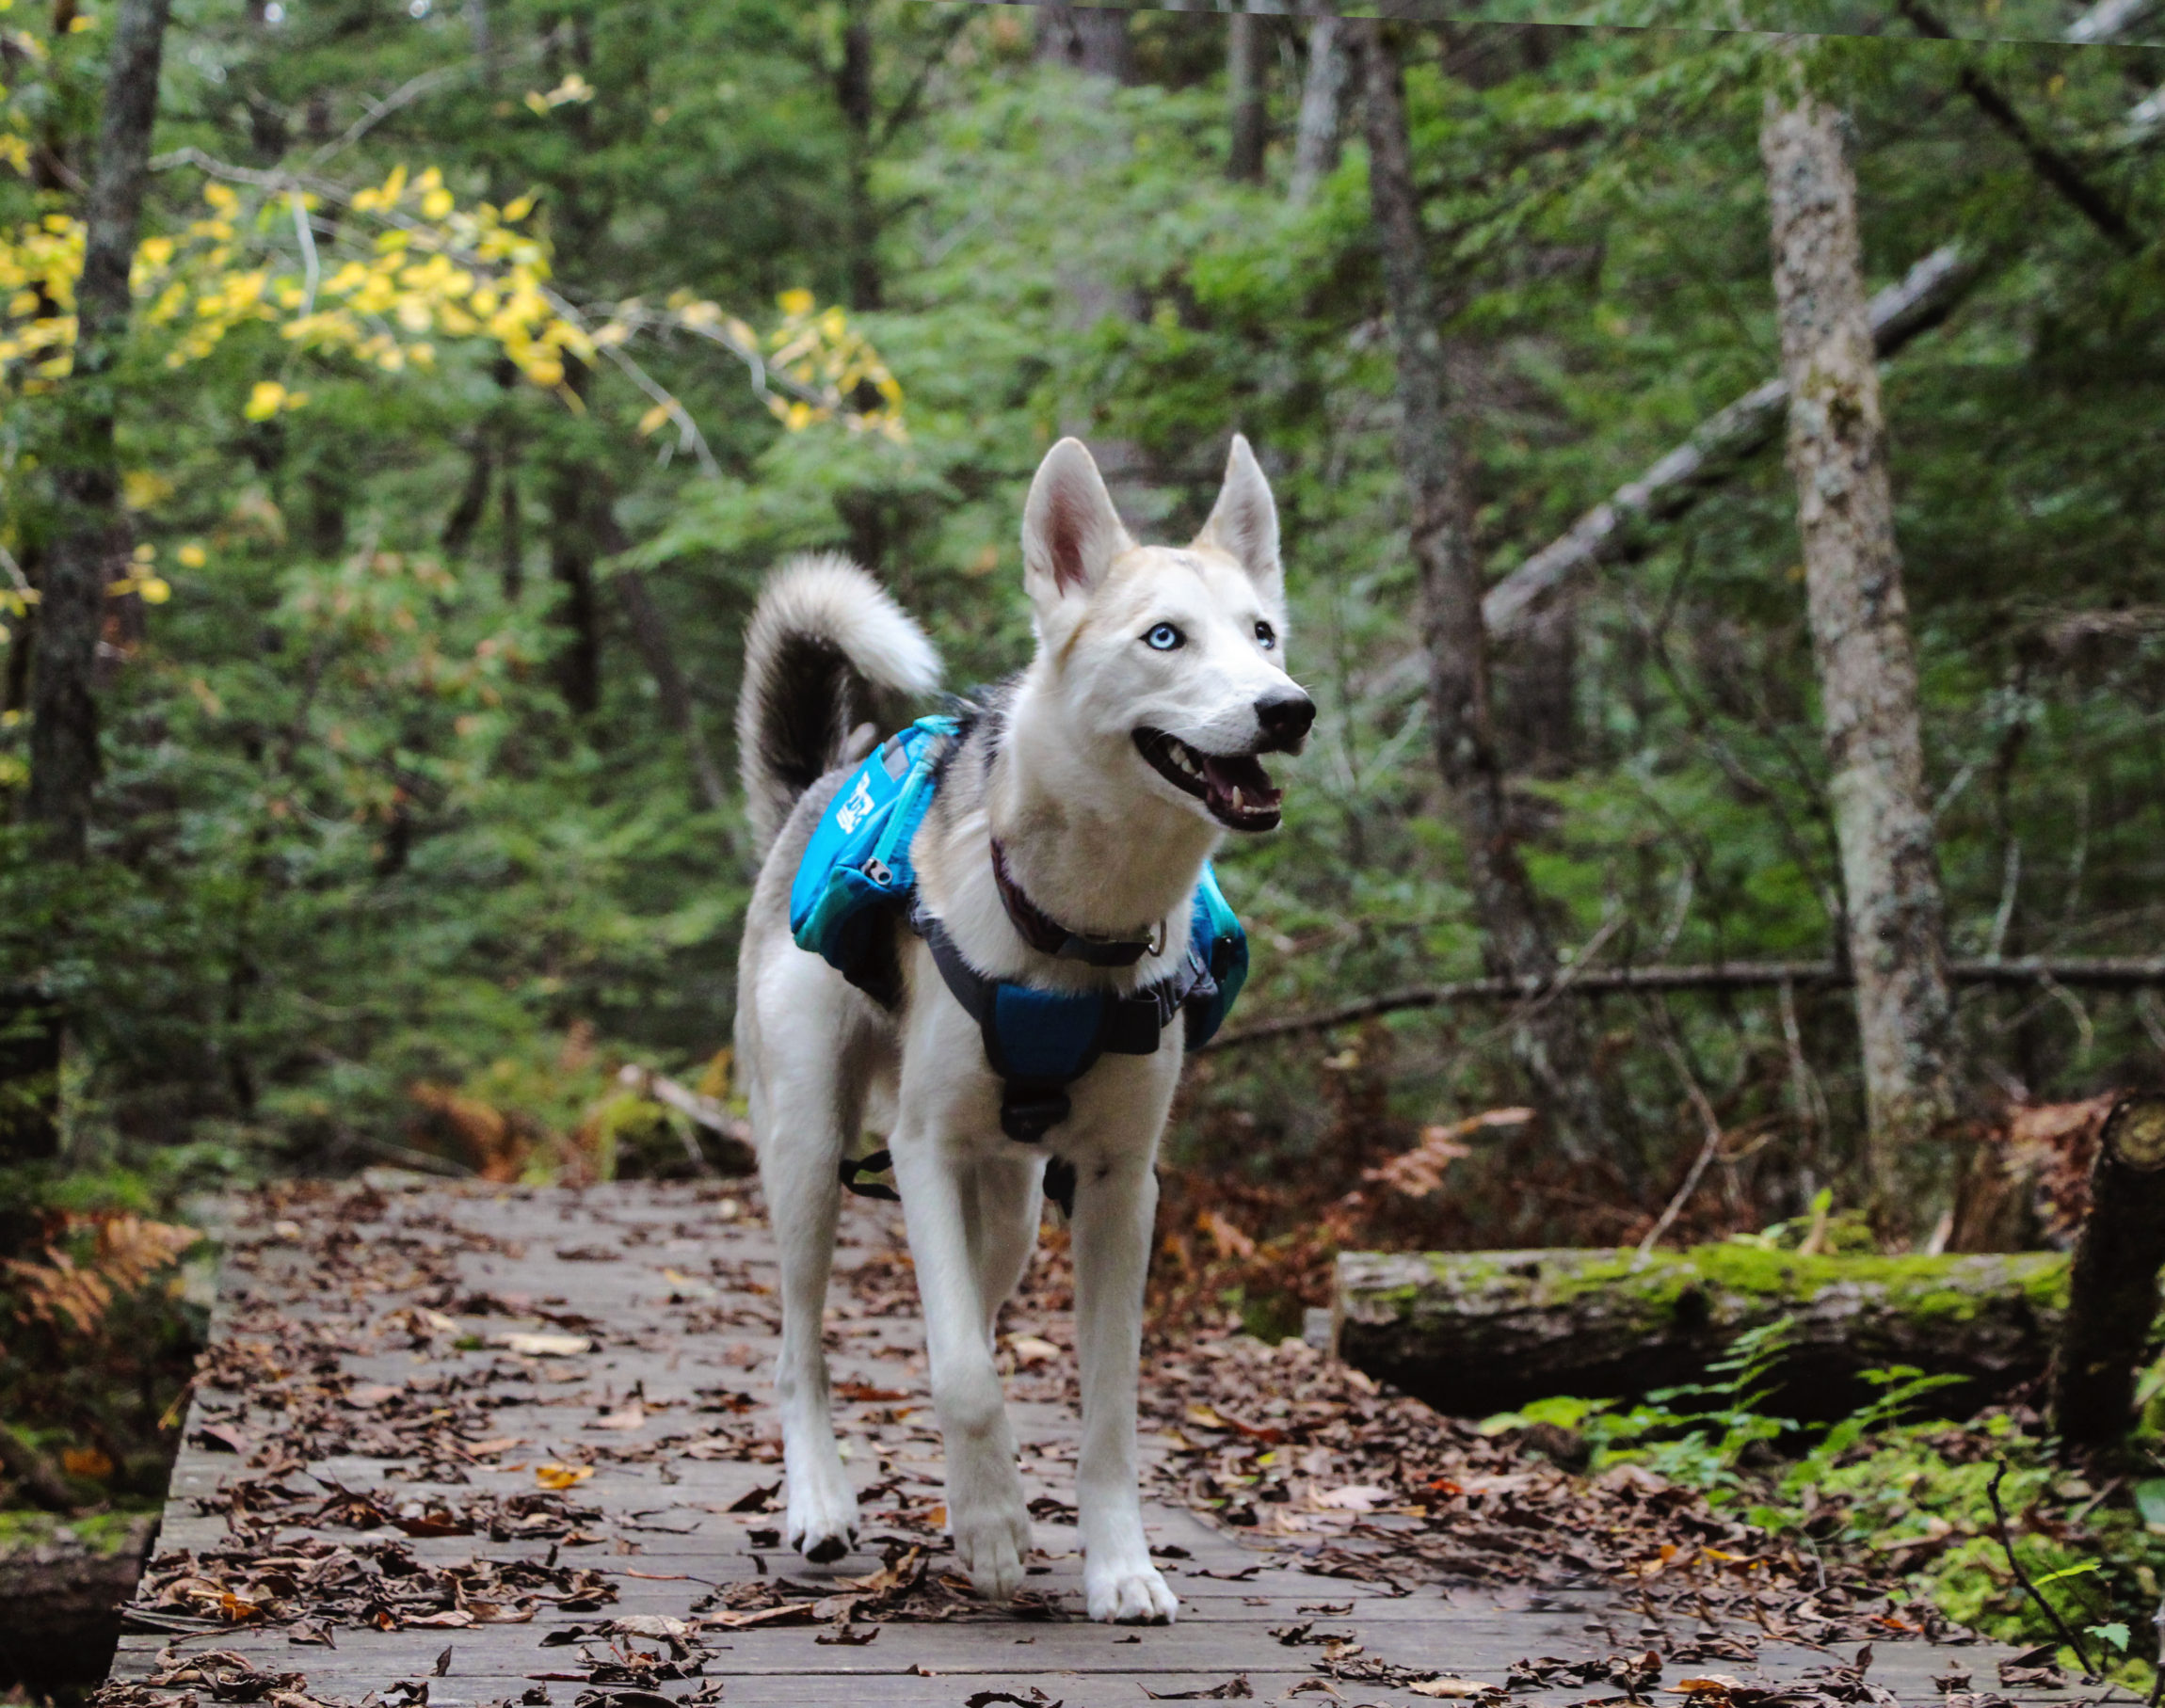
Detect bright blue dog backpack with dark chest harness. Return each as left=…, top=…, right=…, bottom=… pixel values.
left=791, top=716, right=1247, bottom=1143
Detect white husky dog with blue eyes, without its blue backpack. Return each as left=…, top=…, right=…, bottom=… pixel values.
left=736, top=438, right=1316, bottom=1623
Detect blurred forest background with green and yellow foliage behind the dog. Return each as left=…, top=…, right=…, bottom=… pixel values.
left=0, top=0, right=2165, bottom=1662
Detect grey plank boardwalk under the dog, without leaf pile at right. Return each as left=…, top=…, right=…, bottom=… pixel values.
left=113, top=1182, right=2087, bottom=1708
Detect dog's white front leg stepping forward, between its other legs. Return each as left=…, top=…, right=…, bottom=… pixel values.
left=894, top=1132, right=1031, bottom=1602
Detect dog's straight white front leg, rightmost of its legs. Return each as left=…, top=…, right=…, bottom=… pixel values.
left=1074, top=1156, right=1178, bottom=1623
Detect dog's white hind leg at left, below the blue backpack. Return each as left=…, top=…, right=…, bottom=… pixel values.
left=753, top=1026, right=861, bottom=1561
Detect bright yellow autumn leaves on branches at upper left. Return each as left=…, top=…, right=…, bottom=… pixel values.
left=0, top=161, right=903, bottom=438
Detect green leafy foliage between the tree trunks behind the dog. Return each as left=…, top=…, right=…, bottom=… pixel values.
left=0, top=0, right=2165, bottom=1252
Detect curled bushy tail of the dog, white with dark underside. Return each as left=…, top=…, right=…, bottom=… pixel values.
left=736, top=552, right=939, bottom=855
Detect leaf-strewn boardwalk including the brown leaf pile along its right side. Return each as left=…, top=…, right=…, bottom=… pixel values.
left=84, top=1175, right=2095, bottom=1708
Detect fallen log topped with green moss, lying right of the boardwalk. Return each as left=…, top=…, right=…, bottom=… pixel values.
left=1332, top=1245, right=2068, bottom=1418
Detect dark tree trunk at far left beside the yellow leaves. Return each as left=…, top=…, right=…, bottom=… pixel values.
left=26, top=0, right=171, bottom=859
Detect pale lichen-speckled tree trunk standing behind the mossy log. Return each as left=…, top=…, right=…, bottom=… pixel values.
left=1760, top=43, right=1960, bottom=1232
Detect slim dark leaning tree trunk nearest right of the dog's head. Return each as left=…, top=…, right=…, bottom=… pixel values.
left=1349, top=20, right=1632, bottom=1172
